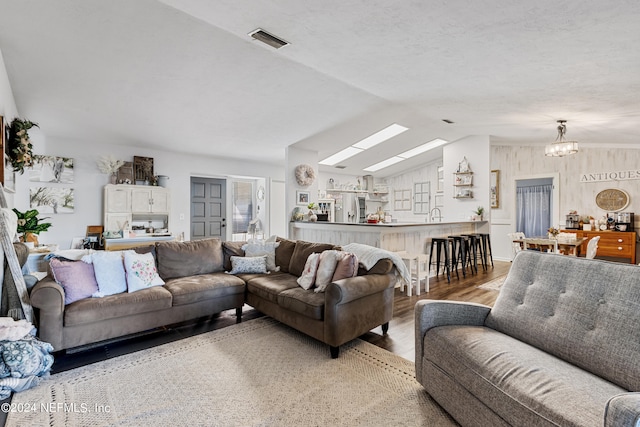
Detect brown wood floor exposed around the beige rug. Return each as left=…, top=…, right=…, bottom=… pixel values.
left=51, top=261, right=511, bottom=374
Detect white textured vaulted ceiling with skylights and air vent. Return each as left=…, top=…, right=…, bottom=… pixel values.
left=0, top=0, right=640, bottom=176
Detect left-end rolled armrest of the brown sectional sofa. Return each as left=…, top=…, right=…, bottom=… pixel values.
left=30, top=276, right=64, bottom=350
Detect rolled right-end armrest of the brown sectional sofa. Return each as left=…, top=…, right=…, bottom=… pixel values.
left=325, top=274, right=395, bottom=305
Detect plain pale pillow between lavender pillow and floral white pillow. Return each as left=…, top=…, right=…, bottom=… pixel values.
left=82, top=251, right=127, bottom=297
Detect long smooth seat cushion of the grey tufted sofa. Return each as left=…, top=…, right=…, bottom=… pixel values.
left=422, top=326, right=626, bottom=426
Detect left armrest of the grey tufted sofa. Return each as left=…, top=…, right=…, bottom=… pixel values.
left=414, top=300, right=491, bottom=378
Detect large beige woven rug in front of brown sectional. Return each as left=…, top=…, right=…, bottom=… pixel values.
left=6, top=317, right=456, bottom=426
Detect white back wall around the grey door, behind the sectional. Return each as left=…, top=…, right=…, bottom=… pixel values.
left=14, top=137, right=284, bottom=248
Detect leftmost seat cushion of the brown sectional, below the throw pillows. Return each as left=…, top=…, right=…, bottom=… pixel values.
left=64, top=286, right=171, bottom=326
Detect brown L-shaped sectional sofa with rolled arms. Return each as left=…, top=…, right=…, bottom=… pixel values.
left=31, top=239, right=395, bottom=357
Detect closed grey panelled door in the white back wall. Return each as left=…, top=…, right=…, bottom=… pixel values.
left=190, top=177, right=227, bottom=240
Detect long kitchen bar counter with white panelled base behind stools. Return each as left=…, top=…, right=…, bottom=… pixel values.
left=289, top=221, right=489, bottom=254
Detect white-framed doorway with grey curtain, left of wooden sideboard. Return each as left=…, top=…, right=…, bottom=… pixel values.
left=515, top=174, right=559, bottom=237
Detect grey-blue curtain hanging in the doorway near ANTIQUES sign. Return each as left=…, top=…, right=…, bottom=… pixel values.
left=516, top=184, right=552, bottom=237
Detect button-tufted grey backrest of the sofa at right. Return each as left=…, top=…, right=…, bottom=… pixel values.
left=486, top=251, right=640, bottom=390
